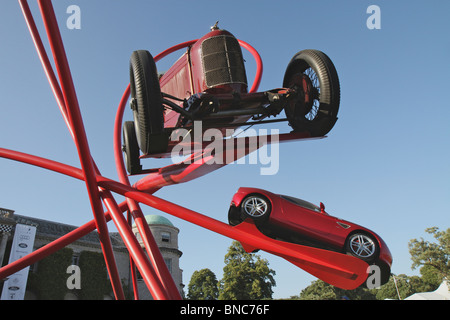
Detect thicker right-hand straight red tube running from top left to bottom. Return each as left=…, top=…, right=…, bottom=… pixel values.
left=38, top=0, right=125, bottom=299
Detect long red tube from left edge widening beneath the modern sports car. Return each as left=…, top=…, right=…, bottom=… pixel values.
left=0, top=148, right=367, bottom=289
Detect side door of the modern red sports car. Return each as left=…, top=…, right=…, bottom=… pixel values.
left=282, top=196, right=335, bottom=241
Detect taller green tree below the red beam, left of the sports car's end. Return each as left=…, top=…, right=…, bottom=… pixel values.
left=219, top=241, right=276, bottom=300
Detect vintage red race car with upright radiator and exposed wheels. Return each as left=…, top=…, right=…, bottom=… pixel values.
left=123, top=24, right=340, bottom=174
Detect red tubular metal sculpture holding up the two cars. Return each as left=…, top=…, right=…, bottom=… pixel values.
left=0, top=0, right=376, bottom=299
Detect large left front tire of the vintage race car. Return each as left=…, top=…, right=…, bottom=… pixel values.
left=130, top=50, right=164, bottom=154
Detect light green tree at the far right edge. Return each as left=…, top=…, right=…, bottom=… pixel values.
left=408, top=227, right=450, bottom=286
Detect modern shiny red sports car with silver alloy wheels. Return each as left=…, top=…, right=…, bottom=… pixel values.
left=228, top=188, right=392, bottom=284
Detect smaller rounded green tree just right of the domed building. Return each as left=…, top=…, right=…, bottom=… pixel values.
left=187, top=268, right=219, bottom=300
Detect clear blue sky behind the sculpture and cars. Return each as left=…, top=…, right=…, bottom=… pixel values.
left=0, top=0, right=450, bottom=298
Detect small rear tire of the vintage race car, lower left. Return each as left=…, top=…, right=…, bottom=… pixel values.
left=123, top=121, right=142, bottom=174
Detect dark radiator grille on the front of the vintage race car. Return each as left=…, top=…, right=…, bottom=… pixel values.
left=202, top=35, right=247, bottom=88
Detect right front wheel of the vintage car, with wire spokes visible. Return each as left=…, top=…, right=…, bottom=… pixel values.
left=283, top=50, right=341, bottom=137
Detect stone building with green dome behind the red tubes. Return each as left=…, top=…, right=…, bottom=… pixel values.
left=0, top=208, right=184, bottom=300
